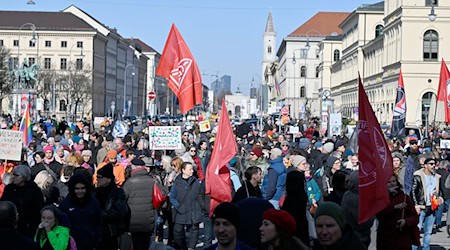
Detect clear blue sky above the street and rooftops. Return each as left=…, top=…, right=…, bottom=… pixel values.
left=0, top=0, right=380, bottom=93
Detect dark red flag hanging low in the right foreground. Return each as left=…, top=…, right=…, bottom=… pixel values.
left=358, top=73, right=393, bottom=223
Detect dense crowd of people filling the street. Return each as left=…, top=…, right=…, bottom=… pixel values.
left=0, top=115, right=450, bottom=250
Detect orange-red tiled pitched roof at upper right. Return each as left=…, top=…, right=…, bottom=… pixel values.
left=288, top=12, right=350, bottom=37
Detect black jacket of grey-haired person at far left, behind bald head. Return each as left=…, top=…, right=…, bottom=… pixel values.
left=1, top=181, right=44, bottom=239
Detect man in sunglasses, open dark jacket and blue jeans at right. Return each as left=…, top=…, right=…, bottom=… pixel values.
left=412, top=158, right=443, bottom=250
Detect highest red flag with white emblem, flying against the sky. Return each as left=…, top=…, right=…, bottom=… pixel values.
left=156, top=24, right=203, bottom=114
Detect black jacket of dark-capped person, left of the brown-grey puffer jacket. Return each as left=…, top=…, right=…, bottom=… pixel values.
left=95, top=182, right=130, bottom=236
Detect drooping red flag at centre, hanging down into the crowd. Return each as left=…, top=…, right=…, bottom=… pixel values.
left=206, top=100, right=237, bottom=216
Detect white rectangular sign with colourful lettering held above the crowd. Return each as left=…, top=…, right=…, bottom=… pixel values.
left=148, top=126, right=183, bottom=150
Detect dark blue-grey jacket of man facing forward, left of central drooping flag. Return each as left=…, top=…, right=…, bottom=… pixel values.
left=170, top=174, right=202, bottom=225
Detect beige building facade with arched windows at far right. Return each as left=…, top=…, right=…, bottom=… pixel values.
left=321, top=0, right=450, bottom=126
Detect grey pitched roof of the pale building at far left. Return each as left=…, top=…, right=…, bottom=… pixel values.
left=0, top=11, right=95, bottom=31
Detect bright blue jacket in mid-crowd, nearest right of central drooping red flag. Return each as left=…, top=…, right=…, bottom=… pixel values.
left=261, top=157, right=287, bottom=201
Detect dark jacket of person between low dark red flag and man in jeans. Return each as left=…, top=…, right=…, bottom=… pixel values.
left=376, top=190, right=419, bottom=250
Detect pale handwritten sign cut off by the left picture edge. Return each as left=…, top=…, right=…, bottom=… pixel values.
left=0, top=129, right=23, bottom=161
